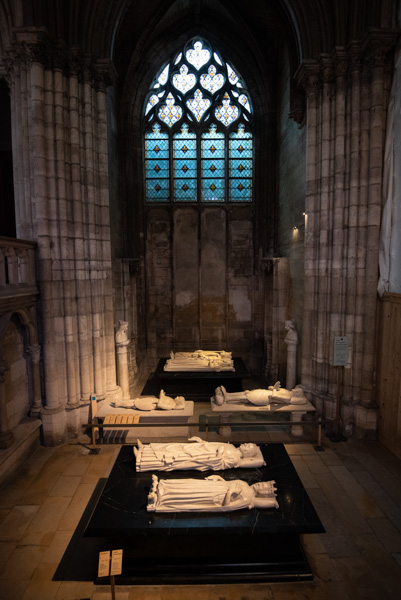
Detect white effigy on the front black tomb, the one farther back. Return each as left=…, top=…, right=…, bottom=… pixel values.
left=134, top=436, right=266, bottom=471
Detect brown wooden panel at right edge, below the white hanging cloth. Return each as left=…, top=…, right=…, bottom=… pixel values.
left=377, top=294, right=401, bottom=458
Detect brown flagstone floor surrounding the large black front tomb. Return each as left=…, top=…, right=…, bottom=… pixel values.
left=0, top=420, right=401, bottom=600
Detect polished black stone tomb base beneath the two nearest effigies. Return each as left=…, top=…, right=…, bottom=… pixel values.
left=79, top=444, right=324, bottom=585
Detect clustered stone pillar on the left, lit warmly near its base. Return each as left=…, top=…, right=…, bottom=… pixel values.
left=4, top=30, right=119, bottom=444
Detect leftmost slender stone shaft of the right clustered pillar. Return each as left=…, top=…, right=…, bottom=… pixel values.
left=301, top=67, right=319, bottom=390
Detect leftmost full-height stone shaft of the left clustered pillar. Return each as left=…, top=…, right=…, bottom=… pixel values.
left=30, top=62, right=62, bottom=412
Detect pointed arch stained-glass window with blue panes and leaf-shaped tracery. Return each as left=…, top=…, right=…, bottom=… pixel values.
left=144, top=37, right=254, bottom=203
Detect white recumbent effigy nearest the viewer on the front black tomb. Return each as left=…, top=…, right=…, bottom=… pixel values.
left=147, top=475, right=278, bottom=512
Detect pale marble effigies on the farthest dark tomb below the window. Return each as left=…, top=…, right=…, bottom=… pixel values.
left=163, top=350, right=235, bottom=372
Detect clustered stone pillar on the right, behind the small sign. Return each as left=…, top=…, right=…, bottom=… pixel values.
left=297, top=31, right=395, bottom=437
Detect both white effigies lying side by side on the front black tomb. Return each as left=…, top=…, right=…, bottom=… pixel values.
left=134, top=437, right=278, bottom=512
